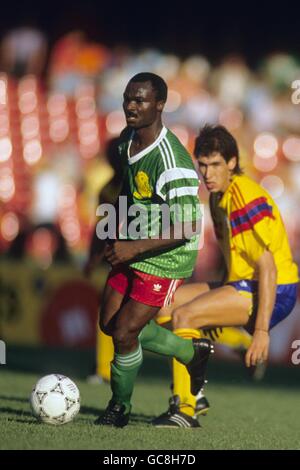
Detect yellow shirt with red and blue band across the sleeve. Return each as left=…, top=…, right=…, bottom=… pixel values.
left=210, top=175, right=299, bottom=284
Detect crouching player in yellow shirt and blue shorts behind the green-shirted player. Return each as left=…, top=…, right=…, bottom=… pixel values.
left=153, top=126, right=299, bottom=427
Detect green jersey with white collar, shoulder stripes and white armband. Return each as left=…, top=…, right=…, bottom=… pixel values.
left=119, top=127, right=200, bottom=279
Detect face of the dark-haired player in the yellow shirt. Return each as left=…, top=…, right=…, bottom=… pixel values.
left=197, top=152, right=236, bottom=193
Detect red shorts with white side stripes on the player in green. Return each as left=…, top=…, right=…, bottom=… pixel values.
left=107, top=265, right=184, bottom=307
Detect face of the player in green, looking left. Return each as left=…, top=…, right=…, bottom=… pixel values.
left=123, top=82, right=163, bottom=129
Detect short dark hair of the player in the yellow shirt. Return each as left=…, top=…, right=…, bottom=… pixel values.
left=194, top=125, right=243, bottom=175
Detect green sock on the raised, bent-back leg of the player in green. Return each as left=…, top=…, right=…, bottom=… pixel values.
left=139, top=320, right=194, bottom=364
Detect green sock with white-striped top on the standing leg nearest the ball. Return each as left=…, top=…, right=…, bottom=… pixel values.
left=110, top=344, right=143, bottom=413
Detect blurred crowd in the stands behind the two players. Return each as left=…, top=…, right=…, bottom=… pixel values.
left=0, top=27, right=300, bottom=277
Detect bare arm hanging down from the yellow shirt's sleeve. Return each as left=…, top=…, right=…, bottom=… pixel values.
left=245, top=250, right=277, bottom=367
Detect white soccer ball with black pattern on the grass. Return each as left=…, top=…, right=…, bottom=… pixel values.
left=30, top=374, right=80, bottom=425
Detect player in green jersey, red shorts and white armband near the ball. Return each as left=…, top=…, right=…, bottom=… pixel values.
left=96, top=73, right=212, bottom=427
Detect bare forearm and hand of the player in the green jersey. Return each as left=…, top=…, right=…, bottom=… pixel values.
left=105, top=221, right=201, bottom=266
